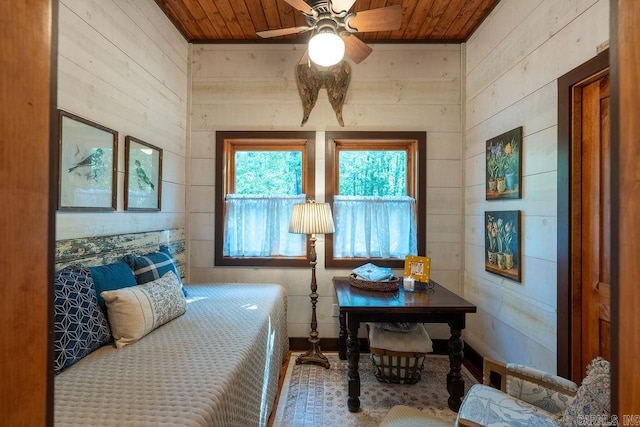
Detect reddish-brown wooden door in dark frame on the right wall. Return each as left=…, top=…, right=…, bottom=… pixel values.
left=571, top=70, right=611, bottom=382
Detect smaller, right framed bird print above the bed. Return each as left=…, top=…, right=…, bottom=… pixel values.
left=124, top=136, right=162, bottom=211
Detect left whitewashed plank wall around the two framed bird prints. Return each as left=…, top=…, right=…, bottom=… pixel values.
left=56, top=0, right=189, bottom=240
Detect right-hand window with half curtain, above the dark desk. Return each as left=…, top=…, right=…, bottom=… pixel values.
left=325, top=132, right=426, bottom=268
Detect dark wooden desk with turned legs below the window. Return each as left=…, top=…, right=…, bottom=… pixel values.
left=333, top=277, right=476, bottom=412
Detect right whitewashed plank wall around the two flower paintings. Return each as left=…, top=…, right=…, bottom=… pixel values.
left=463, top=0, right=609, bottom=372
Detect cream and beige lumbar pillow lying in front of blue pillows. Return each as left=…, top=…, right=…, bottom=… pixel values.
left=102, top=271, right=187, bottom=348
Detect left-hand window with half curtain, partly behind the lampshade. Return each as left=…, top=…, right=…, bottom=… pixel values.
left=215, top=132, right=315, bottom=267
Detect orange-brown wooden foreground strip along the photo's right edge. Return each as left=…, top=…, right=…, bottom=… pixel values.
left=611, top=0, right=640, bottom=416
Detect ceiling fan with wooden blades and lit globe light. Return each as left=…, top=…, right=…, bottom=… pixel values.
left=257, top=0, right=402, bottom=67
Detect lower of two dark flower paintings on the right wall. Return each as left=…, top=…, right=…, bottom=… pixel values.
left=484, top=211, right=522, bottom=282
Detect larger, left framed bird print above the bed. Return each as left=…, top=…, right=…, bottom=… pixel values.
left=58, top=110, right=118, bottom=211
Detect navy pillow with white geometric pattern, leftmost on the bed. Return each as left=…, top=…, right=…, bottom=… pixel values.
left=53, top=265, right=111, bottom=374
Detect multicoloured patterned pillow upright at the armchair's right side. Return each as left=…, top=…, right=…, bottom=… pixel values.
left=562, top=357, right=611, bottom=426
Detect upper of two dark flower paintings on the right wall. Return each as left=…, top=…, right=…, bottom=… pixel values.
left=486, top=126, right=522, bottom=200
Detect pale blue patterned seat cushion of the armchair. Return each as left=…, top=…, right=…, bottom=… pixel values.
left=456, top=384, right=560, bottom=427
